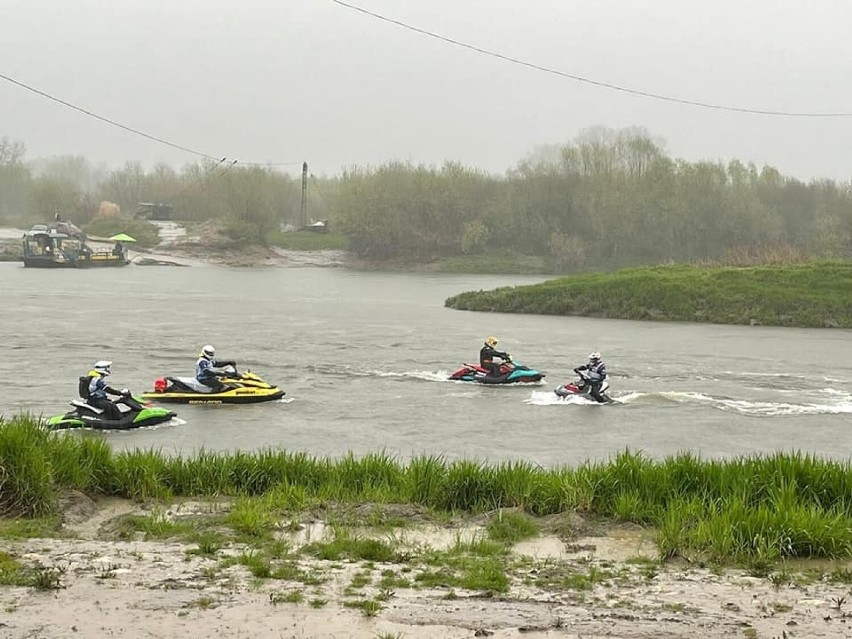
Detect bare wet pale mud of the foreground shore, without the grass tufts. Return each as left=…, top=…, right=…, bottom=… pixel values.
left=0, top=500, right=852, bottom=639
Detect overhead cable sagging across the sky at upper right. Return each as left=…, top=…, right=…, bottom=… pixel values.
left=331, top=0, right=852, bottom=118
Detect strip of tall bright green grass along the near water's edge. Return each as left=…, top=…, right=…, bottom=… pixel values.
left=5, top=417, right=852, bottom=563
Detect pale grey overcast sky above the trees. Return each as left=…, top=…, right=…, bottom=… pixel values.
left=0, top=0, right=852, bottom=180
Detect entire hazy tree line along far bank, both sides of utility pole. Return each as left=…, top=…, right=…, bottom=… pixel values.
left=0, top=128, right=852, bottom=271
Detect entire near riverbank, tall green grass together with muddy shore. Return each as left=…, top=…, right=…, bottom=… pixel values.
left=5, top=417, right=852, bottom=639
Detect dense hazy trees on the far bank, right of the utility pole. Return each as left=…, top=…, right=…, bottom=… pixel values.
left=335, top=128, right=852, bottom=271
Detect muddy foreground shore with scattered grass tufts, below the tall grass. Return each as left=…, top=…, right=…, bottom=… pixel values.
left=6, top=493, right=852, bottom=639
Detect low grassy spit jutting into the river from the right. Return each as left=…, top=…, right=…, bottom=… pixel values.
left=446, top=262, right=852, bottom=328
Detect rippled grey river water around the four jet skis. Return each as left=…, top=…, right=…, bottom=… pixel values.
left=0, top=264, right=852, bottom=466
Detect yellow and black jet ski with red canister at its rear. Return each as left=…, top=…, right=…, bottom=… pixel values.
left=142, top=366, right=284, bottom=404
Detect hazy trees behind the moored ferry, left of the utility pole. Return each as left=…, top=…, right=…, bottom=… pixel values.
left=0, top=137, right=316, bottom=243
